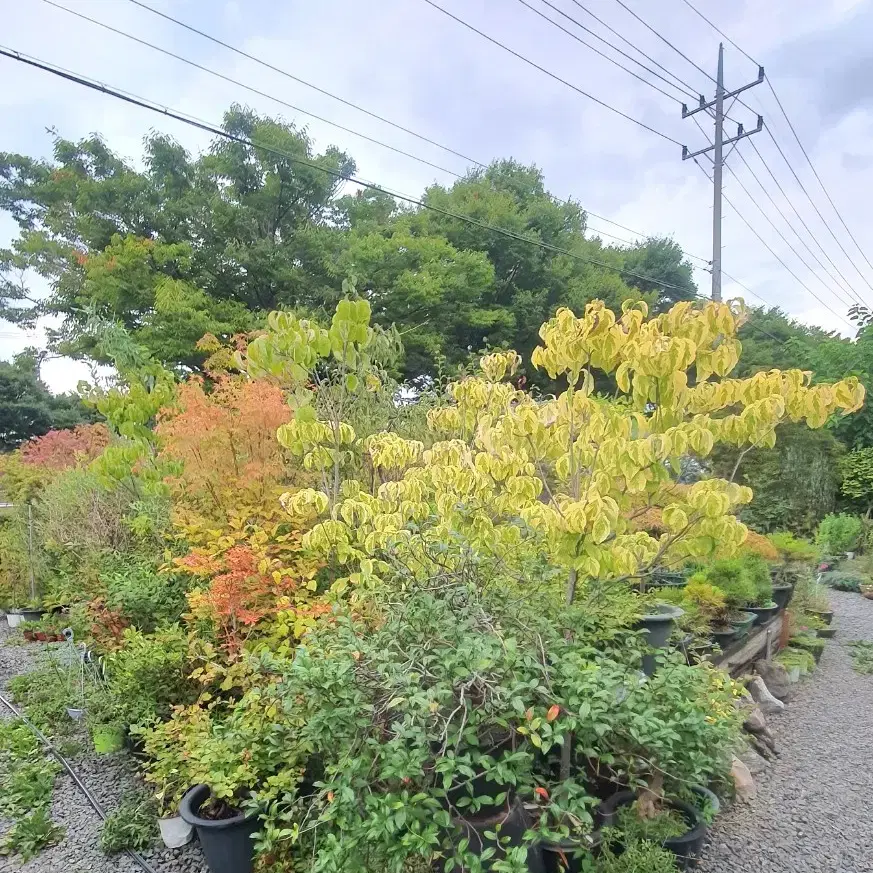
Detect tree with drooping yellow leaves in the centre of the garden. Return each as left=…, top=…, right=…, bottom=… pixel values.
left=242, top=300, right=864, bottom=602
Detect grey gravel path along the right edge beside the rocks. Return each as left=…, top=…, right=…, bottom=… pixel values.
left=699, top=591, right=873, bottom=873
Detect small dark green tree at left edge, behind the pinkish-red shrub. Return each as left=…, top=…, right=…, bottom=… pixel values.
left=0, top=351, right=93, bottom=451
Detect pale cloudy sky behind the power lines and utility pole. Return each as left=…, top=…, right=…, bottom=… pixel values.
left=0, top=0, right=873, bottom=391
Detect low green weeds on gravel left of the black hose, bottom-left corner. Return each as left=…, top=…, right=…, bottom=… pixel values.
left=0, top=719, right=63, bottom=862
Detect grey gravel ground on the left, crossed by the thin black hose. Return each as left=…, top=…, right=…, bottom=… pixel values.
left=0, top=618, right=208, bottom=873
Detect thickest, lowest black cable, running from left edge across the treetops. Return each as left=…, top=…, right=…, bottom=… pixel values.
left=0, top=46, right=700, bottom=300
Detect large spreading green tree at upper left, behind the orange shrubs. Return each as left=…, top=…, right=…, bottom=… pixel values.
left=0, top=106, right=354, bottom=367
